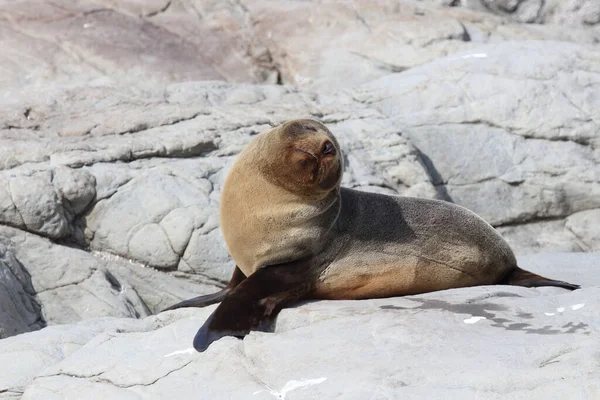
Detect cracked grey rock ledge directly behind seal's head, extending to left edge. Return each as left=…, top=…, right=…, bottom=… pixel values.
left=0, top=83, right=436, bottom=282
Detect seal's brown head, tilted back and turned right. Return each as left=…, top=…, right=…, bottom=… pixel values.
left=260, top=119, right=344, bottom=195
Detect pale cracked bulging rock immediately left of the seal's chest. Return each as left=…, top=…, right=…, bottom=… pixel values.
left=87, top=167, right=211, bottom=268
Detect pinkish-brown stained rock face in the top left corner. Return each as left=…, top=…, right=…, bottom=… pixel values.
left=0, top=1, right=252, bottom=90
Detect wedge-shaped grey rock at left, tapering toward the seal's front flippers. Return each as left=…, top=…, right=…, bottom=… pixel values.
left=0, top=227, right=217, bottom=326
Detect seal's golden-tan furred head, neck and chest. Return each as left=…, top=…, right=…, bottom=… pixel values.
left=220, top=120, right=342, bottom=276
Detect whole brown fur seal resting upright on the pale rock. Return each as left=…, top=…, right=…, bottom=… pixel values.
left=162, top=119, right=579, bottom=351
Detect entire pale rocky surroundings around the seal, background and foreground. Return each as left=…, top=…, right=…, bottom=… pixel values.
left=0, top=0, right=600, bottom=399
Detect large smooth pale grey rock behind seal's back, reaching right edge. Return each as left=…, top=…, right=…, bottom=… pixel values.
left=355, top=41, right=600, bottom=244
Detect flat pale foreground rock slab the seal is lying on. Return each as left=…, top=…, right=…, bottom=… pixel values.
left=0, top=253, right=600, bottom=399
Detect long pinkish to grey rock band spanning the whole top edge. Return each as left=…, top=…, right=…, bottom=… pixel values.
left=0, top=0, right=600, bottom=94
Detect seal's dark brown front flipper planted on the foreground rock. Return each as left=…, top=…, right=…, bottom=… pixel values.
left=194, top=262, right=314, bottom=352
